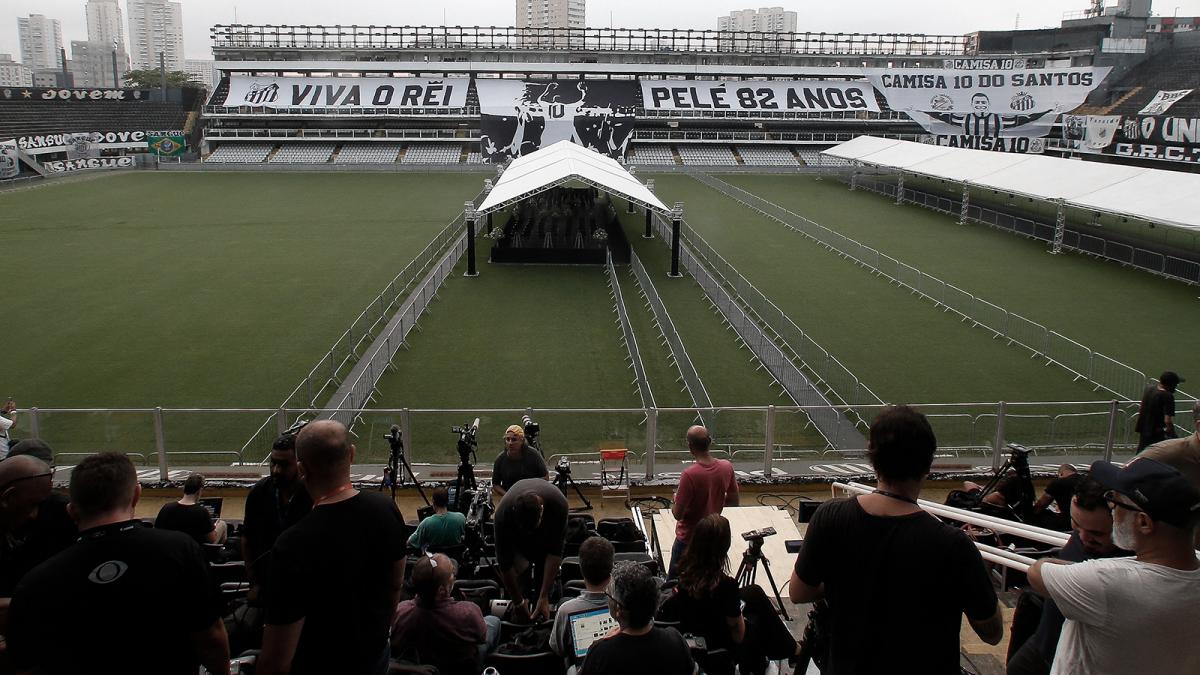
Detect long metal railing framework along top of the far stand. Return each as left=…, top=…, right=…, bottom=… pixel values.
left=210, top=24, right=970, bottom=56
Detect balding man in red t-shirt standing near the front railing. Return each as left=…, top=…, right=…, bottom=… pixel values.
left=668, top=425, right=738, bottom=577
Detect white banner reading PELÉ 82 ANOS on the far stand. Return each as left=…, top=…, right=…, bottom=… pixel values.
left=642, top=79, right=880, bottom=113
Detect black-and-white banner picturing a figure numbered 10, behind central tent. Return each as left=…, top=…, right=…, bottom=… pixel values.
left=475, top=79, right=637, bottom=160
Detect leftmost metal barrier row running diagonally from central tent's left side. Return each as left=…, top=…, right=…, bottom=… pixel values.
left=239, top=191, right=484, bottom=459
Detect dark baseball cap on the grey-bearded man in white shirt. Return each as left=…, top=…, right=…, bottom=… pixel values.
left=1092, top=458, right=1200, bottom=528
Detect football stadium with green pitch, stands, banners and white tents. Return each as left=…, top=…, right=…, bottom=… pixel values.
left=0, top=0, right=1200, bottom=675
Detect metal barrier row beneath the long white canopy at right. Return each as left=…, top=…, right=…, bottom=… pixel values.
left=854, top=175, right=1200, bottom=285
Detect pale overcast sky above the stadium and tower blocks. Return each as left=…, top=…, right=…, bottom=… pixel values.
left=0, top=0, right=1200, bottom=60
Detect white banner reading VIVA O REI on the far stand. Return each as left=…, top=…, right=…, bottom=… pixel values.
left=223, top=76, right=470, bottom=108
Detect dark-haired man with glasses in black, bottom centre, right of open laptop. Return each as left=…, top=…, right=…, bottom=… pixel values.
left=580, top=562, right=696, bottom=675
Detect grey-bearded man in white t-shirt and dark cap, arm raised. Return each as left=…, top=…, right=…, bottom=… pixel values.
left=1028, top=459, right=1200, bottom=675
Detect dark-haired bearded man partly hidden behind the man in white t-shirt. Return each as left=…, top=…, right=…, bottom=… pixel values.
left=1007, top=473, right=1132, bottom=675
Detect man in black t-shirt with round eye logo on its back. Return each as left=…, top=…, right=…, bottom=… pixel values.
left=7, top=453, right=229, bottom=675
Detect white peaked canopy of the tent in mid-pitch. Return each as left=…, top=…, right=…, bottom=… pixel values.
left=479, top=141, right=671, bottom=214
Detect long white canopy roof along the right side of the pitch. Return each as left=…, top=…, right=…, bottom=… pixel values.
left=823, top=136, right=1200, bottom=232
